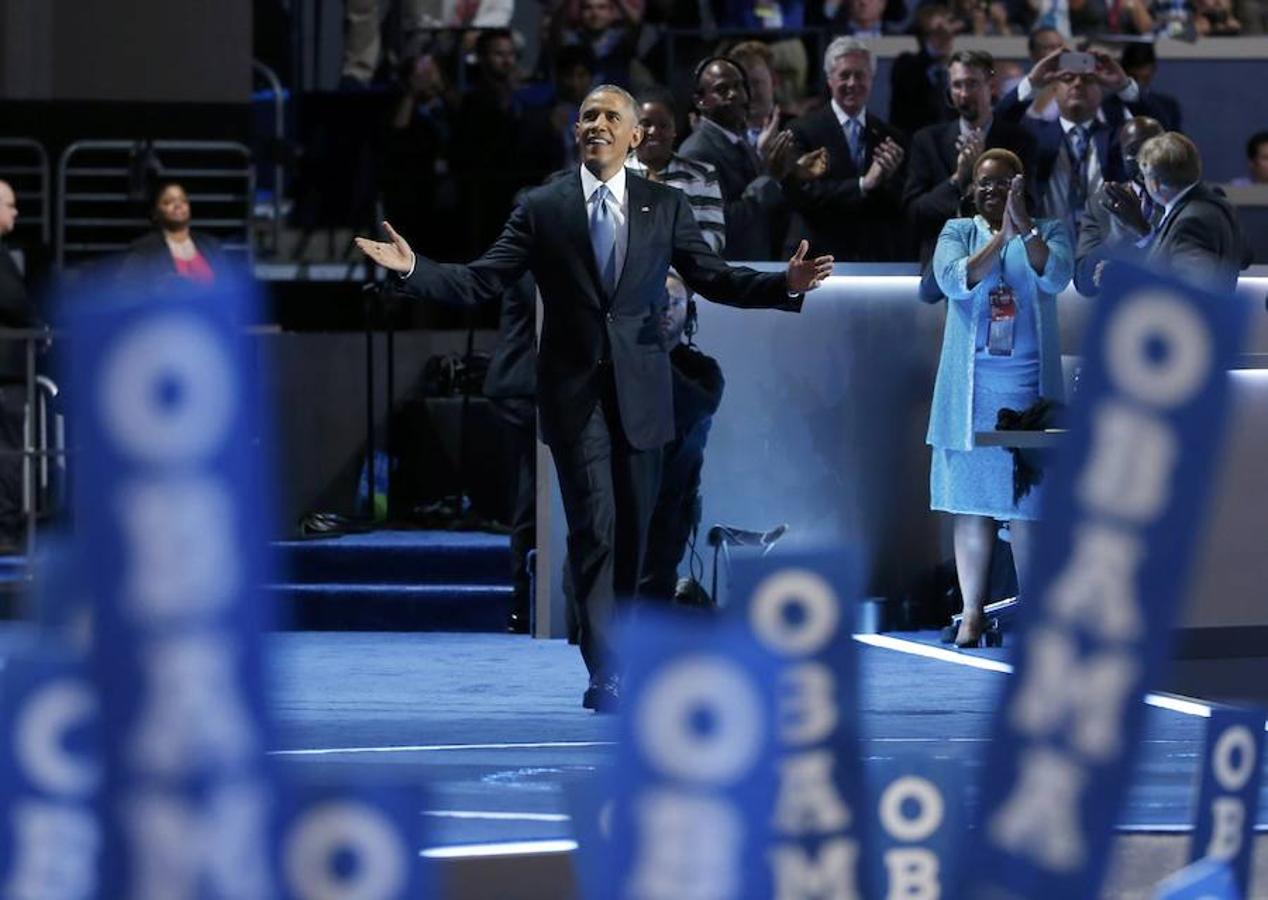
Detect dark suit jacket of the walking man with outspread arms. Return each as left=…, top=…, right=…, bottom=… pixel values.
left=406, top=172, right=801, bottom=450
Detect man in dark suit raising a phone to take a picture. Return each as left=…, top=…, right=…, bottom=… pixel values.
left=995, top=45, right=1156, bottom=240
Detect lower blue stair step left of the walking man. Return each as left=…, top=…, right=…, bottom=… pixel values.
left=269, top=582, right=511, bottom=631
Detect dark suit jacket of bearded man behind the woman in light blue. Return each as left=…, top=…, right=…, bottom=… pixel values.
left=903, top=117, right=1035, bottom=262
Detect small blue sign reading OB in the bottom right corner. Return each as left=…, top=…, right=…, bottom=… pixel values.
left=1189, top=707, right=1264, bottom=896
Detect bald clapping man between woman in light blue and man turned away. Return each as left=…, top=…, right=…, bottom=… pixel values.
left=1074, top=115, right=1165, bottom=297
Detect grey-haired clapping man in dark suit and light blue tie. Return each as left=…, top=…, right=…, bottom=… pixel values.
left=787, top=37, right=914, bottom=262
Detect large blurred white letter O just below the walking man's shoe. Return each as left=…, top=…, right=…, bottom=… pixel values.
left=634, top=655, right=766, bottom=786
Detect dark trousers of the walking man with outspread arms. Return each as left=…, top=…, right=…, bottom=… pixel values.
left=550, top=389, right=661, bottom=678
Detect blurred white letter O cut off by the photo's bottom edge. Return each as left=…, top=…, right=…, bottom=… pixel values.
left=283, top=801, right=412, bottom=900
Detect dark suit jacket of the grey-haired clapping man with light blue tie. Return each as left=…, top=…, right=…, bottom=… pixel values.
left=786, top=105, right=915, bottom=262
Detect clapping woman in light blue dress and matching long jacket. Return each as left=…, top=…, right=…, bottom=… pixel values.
left=927, top=150, right=1074, bottom=646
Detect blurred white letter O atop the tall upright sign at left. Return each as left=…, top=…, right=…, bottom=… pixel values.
left=99, top=314, right=237, bottom=463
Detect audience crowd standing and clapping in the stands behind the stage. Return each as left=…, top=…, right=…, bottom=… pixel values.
left=324, top=0, right=1268, bottom=262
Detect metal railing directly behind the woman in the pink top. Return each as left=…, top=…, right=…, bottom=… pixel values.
left=56, top=141, right=255, bottom=269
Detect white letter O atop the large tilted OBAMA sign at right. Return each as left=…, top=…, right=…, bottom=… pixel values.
left=1106, top=292, right=1212, bottom=408
